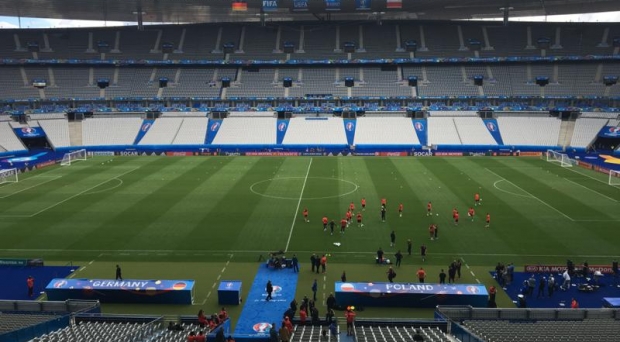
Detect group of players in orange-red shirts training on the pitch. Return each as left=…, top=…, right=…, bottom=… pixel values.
left=302, top=193, right=491, bottom=236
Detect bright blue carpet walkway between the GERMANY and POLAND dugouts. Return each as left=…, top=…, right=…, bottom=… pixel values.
left=234, top=264, right=298, bottom=338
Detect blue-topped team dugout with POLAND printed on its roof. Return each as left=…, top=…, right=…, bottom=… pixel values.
left=336, top=282, right=488, bottom=308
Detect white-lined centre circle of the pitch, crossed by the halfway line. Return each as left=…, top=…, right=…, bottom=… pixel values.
left=250, top=177, right=359, bottom=201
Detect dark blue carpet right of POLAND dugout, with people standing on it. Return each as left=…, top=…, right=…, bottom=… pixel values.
left=490, top=271, right=620, bottom=308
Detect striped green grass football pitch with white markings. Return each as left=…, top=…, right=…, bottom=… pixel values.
left=0, top=157, right=620, bottom=316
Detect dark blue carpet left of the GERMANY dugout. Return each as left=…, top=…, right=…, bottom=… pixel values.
left=0, top=266, right=80, bottom=300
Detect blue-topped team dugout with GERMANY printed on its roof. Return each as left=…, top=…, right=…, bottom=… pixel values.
left=45, top=278, right=194, bottom=304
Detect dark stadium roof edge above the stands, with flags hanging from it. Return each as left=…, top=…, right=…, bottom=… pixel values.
left=0, top=0, right=618, bottom=23
